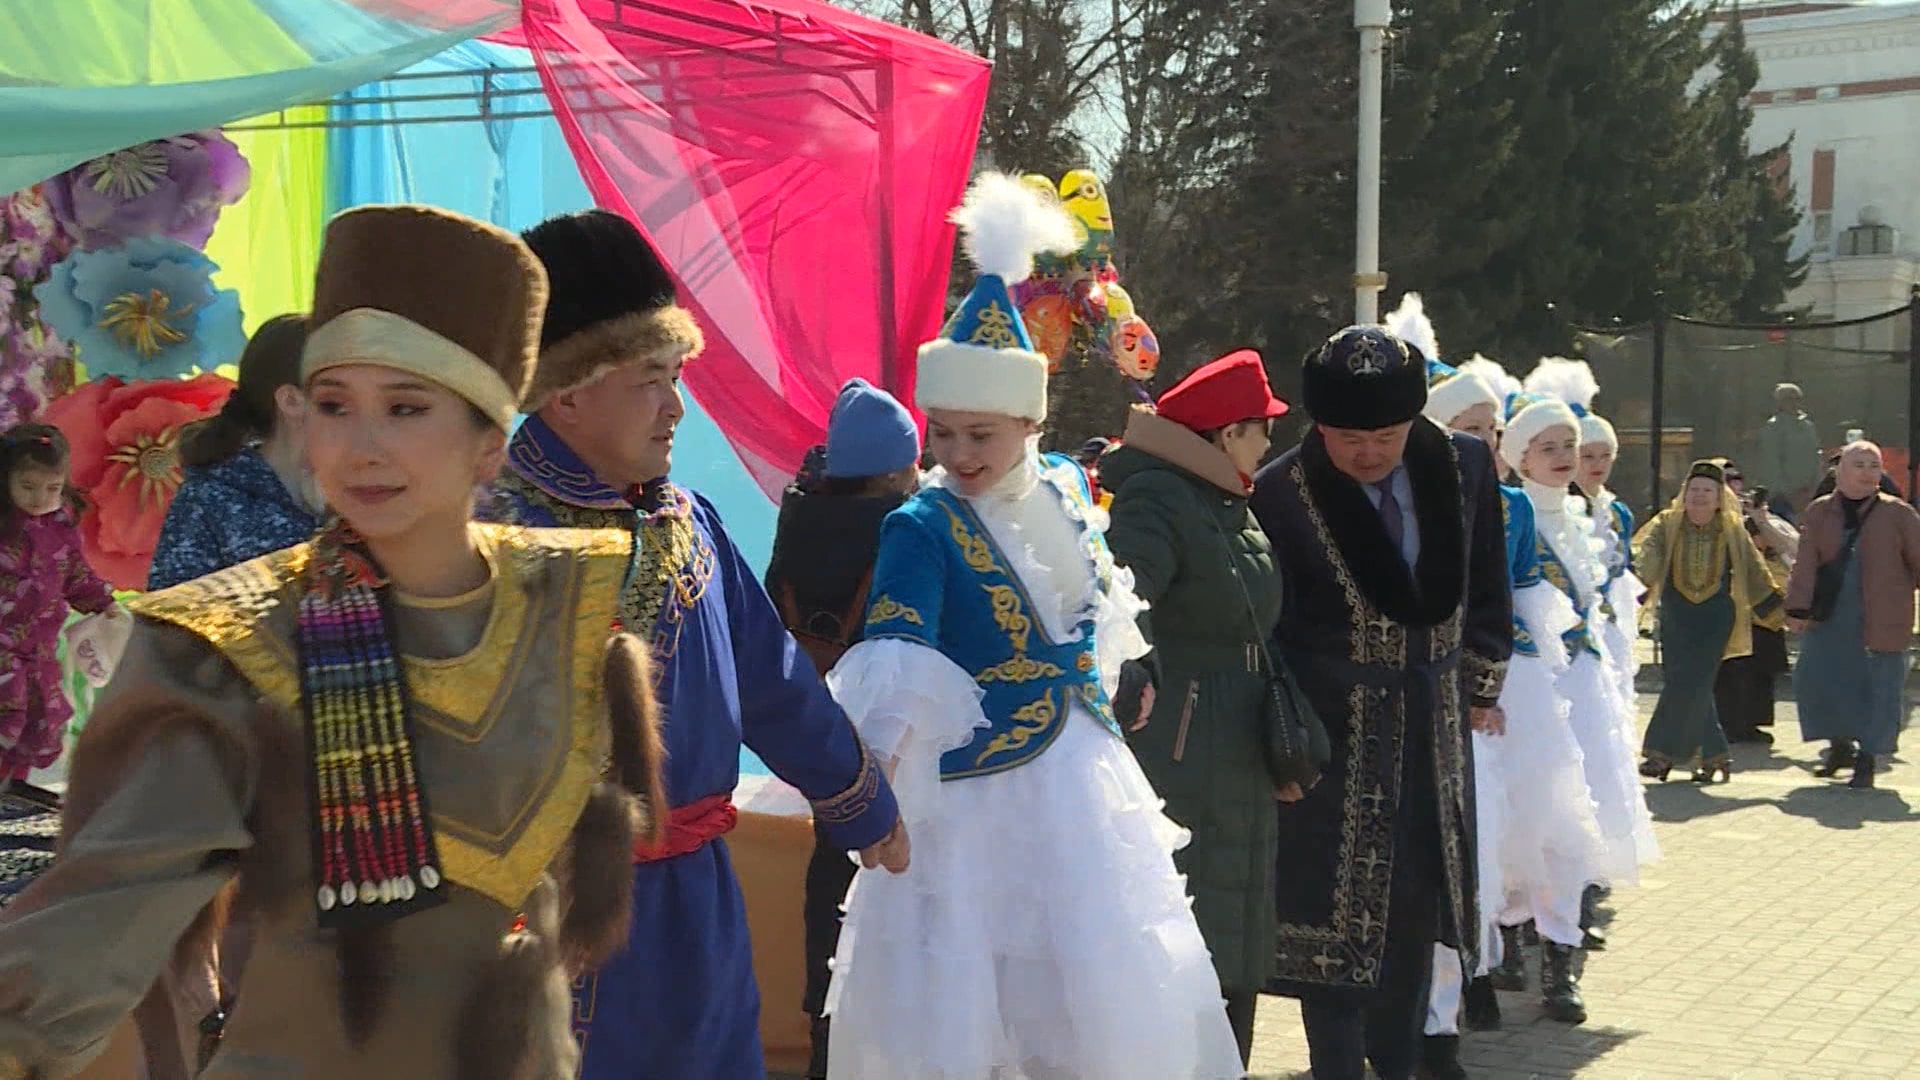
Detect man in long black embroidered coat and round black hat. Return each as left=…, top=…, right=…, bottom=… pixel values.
left=1252, top=327, right=1513, bottom=1080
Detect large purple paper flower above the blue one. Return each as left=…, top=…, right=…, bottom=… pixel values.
left=46, top=131, right=253, bottom=248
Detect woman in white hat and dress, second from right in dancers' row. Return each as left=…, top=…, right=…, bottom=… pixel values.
left=1496, top=376, right=1632, bottom=1022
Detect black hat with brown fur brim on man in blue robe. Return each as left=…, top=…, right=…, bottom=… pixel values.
left=522, top=209, right=705, bottom=413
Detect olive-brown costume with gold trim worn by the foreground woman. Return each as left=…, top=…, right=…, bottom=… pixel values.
left=0, top=525, right=648, bottom=1080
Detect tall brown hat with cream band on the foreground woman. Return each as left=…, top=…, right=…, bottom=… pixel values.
left=300, top=206, right=547, bottom=430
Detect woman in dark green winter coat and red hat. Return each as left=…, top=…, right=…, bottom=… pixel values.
left=1100, top=352, right=1300, bottom=1061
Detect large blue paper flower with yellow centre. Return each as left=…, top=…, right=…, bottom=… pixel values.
left=33, top=236, right=246, bottom=380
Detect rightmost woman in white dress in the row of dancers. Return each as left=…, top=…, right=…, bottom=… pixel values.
left=1526, top=357, right=1659, bottom=907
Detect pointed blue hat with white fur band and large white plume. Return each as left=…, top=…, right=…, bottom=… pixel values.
left=914, top=173, right=1079, bottom=423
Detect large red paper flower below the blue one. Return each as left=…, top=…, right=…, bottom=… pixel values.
left=46, top=375, right=232, bottom=588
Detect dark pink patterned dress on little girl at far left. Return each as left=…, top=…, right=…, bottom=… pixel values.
left=0, top=509, right=113, bottom=780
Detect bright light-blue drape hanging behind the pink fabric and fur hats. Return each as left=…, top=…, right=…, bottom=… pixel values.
left=326, top=40, right=778, bottom=573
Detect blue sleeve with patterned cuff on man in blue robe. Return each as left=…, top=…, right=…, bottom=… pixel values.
left=695, top=496, right=900, bottom=851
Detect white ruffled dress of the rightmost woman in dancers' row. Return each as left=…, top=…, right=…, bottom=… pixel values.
left=1526, top=480, right=1659, bottom=887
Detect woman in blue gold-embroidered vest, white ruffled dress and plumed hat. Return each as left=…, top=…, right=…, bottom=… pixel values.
left=828, top=175, right=1242, bottom=1080
